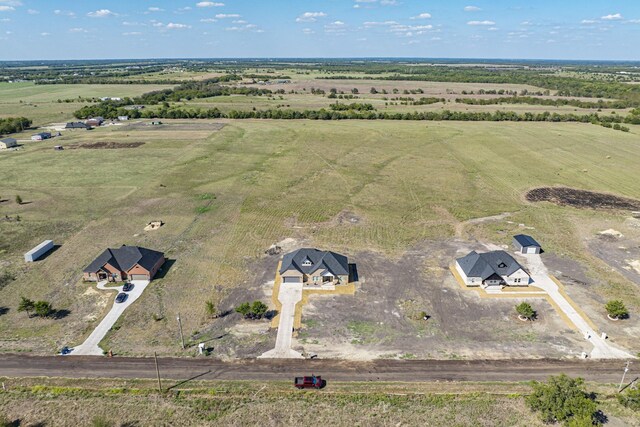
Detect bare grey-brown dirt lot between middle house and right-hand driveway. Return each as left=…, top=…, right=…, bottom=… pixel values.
left=243, top=240, right=586, bottom=360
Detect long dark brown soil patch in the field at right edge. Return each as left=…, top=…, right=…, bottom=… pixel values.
left=526, top=187, right=640, bottom=210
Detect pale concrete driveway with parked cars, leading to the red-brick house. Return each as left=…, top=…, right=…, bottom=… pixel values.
left=69, top=280, right=149, bottom=356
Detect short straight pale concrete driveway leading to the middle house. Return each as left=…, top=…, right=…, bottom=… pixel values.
left=258, top=283, right=304, bottom=359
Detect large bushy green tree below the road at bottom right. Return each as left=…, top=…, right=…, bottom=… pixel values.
left=525, top=374, right=600, bottom=427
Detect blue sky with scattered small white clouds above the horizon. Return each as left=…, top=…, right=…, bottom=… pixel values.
left=0, top=0, right=640, bottom=60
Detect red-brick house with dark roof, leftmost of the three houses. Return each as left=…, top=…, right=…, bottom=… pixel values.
left=83, top=245, right=165, bottom=282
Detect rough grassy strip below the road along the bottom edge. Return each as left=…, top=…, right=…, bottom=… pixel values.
left=0, top=378, right=640, bottom=427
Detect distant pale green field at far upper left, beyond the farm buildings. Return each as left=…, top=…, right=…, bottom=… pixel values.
left=0, top=82, right=173, bottom=126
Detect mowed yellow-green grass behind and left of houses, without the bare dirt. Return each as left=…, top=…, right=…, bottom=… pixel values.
left=0, top=121, right=640, bottom=354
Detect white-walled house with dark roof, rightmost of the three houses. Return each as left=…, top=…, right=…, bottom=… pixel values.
left=456, top=251, right=531, bottom=289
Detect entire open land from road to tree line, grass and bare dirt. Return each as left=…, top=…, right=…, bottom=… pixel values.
left=0, top=120, right=640, bottom=359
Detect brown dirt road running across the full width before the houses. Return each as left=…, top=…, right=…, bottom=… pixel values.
left=0, top=354, right=640, bottom=384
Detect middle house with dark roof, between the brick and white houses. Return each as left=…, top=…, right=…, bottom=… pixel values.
left=279, top=248, right=349, bottom=286
